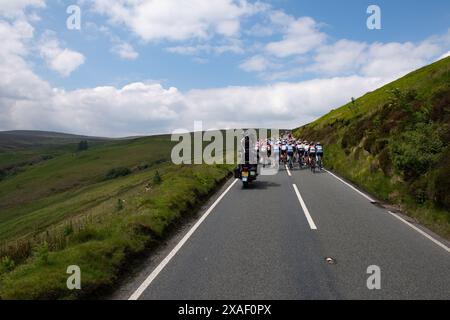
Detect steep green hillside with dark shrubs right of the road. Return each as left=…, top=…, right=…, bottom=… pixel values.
left=294, top=58, right=450, bottom=239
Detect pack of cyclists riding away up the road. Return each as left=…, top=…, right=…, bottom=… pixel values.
left=256, top=134, right=324, bottom=171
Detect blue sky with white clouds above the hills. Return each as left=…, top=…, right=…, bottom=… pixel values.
left=0, top=0, right=450, bottom=137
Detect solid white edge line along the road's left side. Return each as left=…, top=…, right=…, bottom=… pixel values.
left=128, top=179, right=238, bottom=300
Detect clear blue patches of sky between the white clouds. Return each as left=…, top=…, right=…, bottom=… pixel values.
left=30, top=0, right=450, bottom=90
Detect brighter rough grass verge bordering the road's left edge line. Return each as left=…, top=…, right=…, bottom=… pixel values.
left=0, top=165, right=230, bottom=300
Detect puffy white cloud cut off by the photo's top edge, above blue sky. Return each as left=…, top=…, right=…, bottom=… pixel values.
left=89, top=0, right=264, bottom=41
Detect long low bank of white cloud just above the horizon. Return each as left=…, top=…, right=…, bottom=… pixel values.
left=2, top=77, right=383, bottom=136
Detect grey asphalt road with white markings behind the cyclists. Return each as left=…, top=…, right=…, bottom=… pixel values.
left=121, top=165, right=450, bottom=300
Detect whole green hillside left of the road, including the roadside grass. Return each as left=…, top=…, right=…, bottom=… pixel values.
left=0, top=131, right=230, bottom=299
